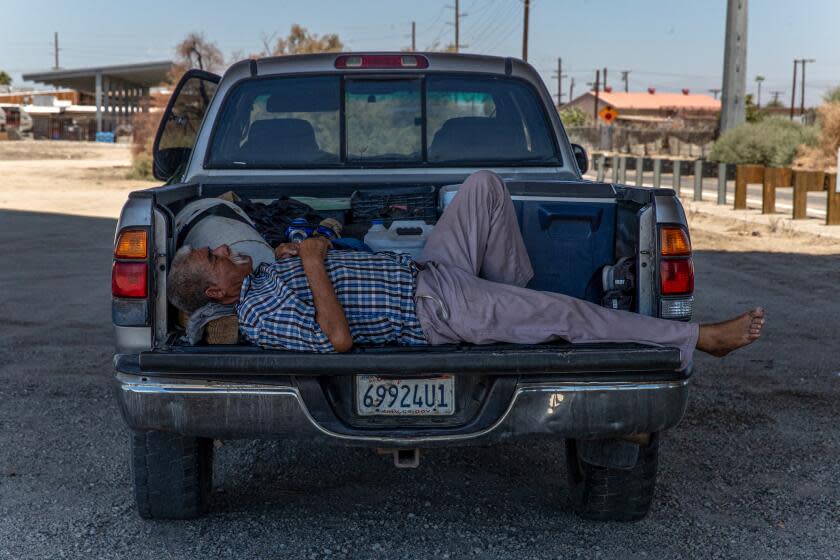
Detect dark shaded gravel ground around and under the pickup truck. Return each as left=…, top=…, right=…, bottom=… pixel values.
left=0, top=211, right=840, bottom=560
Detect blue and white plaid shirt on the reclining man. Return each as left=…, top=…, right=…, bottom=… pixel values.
left=236, top=250, right=428, bottom=352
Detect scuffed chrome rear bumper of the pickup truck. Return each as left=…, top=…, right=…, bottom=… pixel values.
left=116, top=373, right=688, bottom=447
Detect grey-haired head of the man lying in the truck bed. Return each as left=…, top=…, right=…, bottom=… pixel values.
left=167, top=245, right=251, bottom=313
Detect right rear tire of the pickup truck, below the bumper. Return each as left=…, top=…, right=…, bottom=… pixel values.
left=566, top=434, right=659, bottom=521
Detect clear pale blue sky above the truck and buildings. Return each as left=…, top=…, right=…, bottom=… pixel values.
left=0, top=0, right=840, bottom=105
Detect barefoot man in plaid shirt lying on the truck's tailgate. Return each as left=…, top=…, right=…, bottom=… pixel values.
left=168, top=171, right=764, bottom=368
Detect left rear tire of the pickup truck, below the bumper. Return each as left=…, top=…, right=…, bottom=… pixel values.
left=129, top=431, right=213, bottom=519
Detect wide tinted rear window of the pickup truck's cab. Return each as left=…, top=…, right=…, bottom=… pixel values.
left=205, top=75, right=562, bottom=169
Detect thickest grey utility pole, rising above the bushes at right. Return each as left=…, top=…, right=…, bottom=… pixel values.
left=720, top=0, right=747, bottom=134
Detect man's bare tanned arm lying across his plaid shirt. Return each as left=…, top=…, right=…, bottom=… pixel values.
left=298, top=237, right=353, bottom=352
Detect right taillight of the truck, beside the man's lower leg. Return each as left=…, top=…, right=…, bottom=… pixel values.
left=659, top=225, right=694, bottom=320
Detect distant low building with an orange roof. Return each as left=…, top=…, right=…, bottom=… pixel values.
left=562, top=88, right=720, bottom=127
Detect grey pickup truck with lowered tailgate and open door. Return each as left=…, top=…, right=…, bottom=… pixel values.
left=112, top=53, right=693, bottom=521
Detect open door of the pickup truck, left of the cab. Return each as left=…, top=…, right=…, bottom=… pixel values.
left=153, top=70, right=221, bottom=181
